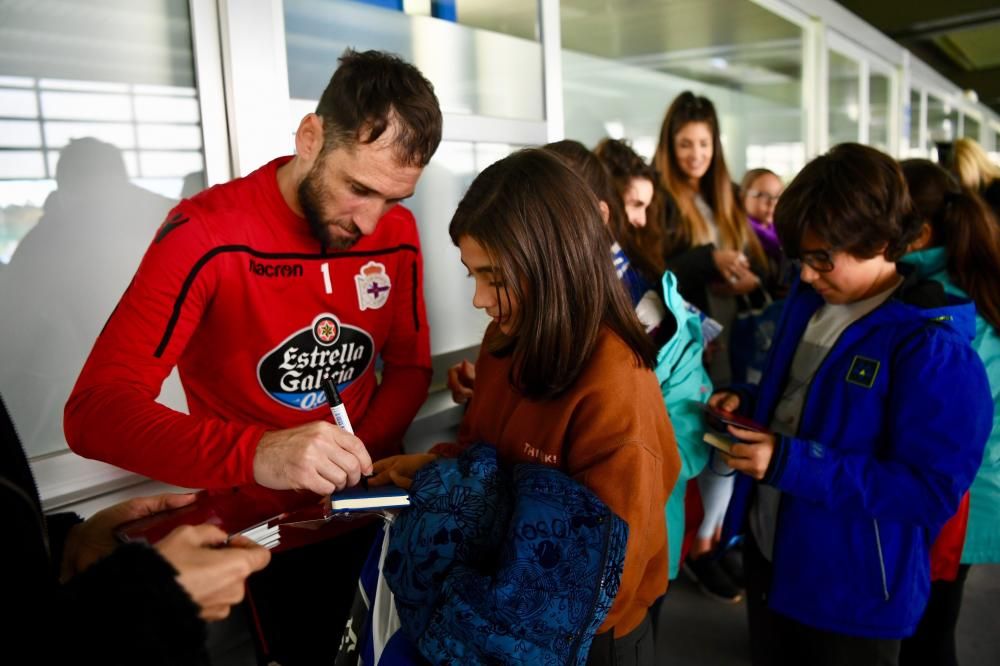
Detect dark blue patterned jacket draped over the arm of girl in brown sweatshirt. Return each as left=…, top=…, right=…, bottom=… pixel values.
left=383, top=444, right=628, bottom=666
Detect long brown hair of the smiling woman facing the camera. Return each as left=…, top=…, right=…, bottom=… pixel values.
left=653, top=91, right=767, bottom=266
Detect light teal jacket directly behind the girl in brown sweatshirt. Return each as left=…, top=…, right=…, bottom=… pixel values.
left=656, top=271, right=712, bottom=580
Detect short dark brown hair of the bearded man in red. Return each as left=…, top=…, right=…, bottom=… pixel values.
left=316, top=49, right=441, bottom=167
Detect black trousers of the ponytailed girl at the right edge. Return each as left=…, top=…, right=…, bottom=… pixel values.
left=899, top=564, right=969, bottom=666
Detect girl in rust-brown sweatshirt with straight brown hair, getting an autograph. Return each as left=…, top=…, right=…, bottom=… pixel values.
left=372, top=149, right=680, bottom=664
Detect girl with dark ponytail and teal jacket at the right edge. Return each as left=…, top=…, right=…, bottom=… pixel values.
left=900, top=159, right=1000, bottom=666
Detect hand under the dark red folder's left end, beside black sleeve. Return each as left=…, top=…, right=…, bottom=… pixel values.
left=60, top=493, right=195, bottom=582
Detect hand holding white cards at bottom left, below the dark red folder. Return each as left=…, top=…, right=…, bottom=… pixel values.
left=155, top=525, right=271, bottom=621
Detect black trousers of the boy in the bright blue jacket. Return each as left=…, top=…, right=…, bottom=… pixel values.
left=743, top=533, right=900, bottom=666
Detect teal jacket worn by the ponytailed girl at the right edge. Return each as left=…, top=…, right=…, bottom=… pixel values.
left=902, top=247, right=1000, bottom=564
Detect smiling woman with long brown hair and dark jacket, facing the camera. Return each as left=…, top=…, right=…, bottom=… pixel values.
left=652, top=92, right=767, bottom=602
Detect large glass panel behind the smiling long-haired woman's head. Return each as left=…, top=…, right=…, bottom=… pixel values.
left=560, top=0, right=805, bottom=180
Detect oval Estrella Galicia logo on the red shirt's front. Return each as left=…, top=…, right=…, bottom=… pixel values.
left=257, top=312, right=375, bottom=411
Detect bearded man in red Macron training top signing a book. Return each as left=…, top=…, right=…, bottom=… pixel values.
left=65, top=51, right=441, bottom=666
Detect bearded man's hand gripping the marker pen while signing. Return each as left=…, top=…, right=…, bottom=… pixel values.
left=253, top=421, right=372, bottom=495
